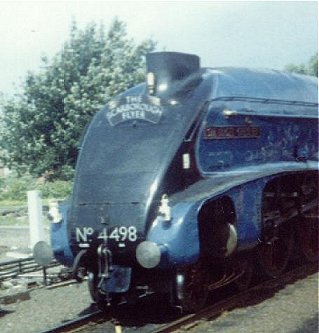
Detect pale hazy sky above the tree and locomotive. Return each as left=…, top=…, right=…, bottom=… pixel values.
left=0, top=0, right=318, bottom=97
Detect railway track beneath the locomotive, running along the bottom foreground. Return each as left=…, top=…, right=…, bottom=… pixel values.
left=37, top=263, right=318, bottom=333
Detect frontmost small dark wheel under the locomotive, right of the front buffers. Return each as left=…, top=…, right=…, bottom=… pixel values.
left=176, top=261, right=209, bottom=313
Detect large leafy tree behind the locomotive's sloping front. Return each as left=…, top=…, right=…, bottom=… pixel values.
left=0, top=19, right=155, bottom=178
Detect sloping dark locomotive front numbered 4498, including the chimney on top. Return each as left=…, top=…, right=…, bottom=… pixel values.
left=68, top=52, right=206, bottom=264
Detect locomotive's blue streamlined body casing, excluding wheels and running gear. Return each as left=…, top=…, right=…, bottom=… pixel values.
left=51, top=52, right=318, bottom=293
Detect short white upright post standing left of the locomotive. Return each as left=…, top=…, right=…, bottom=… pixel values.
left=28, top=190, right=44, bottom=249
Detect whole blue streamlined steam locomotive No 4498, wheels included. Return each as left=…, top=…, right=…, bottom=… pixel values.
left=47, top=52, right=318, bottom=311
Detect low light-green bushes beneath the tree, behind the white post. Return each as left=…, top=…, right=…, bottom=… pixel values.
left=0, top=176, right=72, bottom=204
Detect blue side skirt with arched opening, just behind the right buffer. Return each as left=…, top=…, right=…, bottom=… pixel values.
left=147, top=177, right=269, bottom=269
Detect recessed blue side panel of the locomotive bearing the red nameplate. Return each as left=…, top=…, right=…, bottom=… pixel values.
left=197, top=101, right=318, bottom=175
